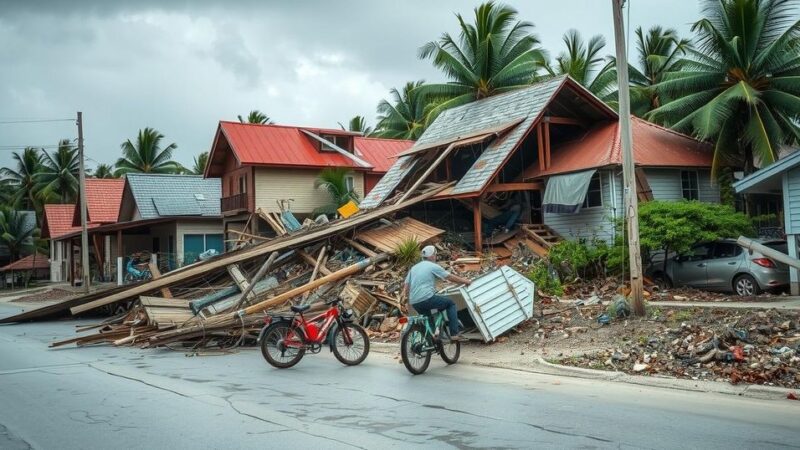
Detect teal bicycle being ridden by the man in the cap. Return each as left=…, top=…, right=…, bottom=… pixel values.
left=400, top=310, right=461, bottom=375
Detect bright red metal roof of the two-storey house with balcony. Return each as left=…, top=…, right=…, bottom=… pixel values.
left=211, top=121, right=413, bottom=172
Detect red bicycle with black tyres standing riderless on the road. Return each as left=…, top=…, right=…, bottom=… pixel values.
left=258, top=298, right=369, bottom=369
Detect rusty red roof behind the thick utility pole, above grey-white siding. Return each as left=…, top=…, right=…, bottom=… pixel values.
left=524, top=117, right=713, bottom=179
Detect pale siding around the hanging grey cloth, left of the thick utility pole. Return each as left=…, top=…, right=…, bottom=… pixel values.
left=544, top=170, right=622, bottom=243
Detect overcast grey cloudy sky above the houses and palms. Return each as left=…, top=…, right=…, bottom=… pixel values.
left=0, top=0, right=700, bottom=171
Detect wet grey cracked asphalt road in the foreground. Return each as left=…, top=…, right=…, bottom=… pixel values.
left=0, top=305, right=800, bottom=450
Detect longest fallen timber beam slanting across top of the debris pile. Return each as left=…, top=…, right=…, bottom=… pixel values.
left=70, top=184, right=450, bottom=314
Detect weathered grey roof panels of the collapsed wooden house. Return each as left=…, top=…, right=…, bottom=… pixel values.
left=359, top=76, right=567, bottom=208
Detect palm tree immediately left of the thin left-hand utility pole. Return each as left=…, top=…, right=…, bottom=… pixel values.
left=36, top=139, right=80, bottom=203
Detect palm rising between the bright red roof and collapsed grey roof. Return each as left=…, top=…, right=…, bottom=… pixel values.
left=374, top=80, right=426, bottom=140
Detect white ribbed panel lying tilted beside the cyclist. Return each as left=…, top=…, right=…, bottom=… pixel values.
left=444, top=266, right=536, bottom=342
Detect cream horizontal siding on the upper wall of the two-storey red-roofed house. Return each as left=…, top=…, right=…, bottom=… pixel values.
left=255, top=168, right=364, bottom=214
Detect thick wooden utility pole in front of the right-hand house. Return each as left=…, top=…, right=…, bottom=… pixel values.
left=611, top=0, right=645, bottom=316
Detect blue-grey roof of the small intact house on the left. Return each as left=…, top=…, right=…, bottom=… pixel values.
left=125, top=173, right=222, bottom=219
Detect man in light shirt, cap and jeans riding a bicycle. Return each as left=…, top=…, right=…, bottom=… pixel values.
left=403, top=245, right=471, bottom=341
